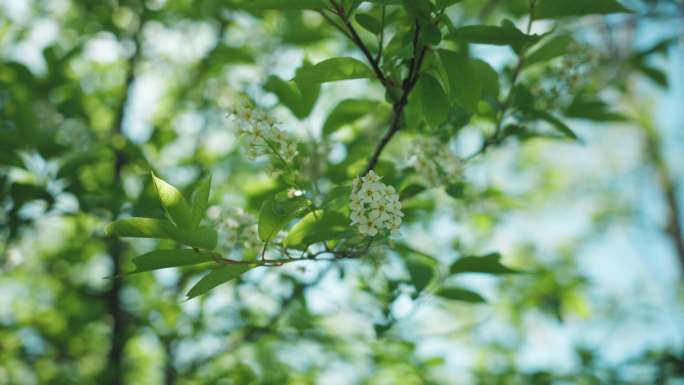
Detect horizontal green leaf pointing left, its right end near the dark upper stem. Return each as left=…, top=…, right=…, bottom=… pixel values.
left=295, top=57, right=373, bottom=83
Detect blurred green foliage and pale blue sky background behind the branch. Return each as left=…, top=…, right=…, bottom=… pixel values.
left=0, top=0, right=684, bottom=385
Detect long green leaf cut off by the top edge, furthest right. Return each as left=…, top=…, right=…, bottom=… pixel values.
left=534, top=0, right=632, bottom=19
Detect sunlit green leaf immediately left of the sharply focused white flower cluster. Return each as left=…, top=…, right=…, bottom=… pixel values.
left=284, top=210, right=354, bottom=248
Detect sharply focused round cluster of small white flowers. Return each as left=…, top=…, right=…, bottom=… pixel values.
left=349, top=170, right=404, bottom=237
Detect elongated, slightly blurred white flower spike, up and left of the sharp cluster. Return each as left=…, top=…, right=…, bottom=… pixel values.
left=230, top=104, right=298, bottom=163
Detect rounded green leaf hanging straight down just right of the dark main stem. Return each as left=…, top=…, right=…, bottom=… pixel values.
left=439, top=50, right=480, bottom=112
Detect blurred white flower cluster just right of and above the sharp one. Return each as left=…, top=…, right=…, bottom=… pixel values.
left=413, top=138, right=461, bottom=187
